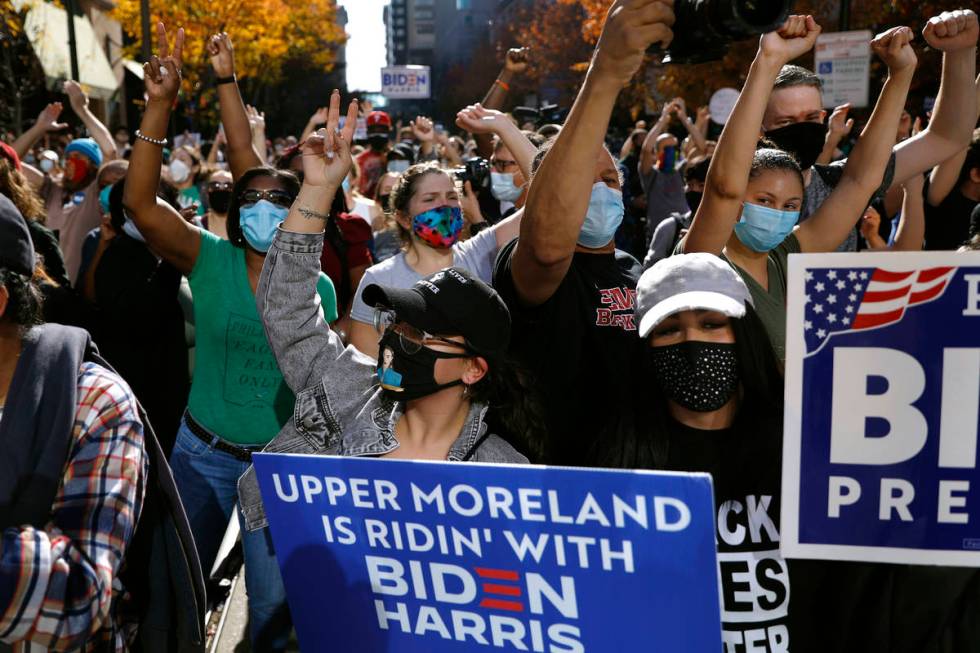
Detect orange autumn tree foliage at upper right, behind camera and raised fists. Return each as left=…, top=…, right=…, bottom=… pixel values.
left=510, top=0, right=969, bottom=119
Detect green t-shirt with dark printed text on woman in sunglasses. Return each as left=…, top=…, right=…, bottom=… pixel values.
left=187, top=230, right=337, bottom=445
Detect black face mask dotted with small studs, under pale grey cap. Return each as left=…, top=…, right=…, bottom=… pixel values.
left=650, top=340, right=739, bottom=413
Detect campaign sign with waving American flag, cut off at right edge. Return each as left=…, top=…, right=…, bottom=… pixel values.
left=781, top=252, right=980, bottom=567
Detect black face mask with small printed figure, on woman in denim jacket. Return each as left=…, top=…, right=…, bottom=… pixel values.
left=378, top=329, right=470, bottom=401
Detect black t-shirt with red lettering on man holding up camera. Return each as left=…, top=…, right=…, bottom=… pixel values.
left=493, top=240, right=643, bottom=465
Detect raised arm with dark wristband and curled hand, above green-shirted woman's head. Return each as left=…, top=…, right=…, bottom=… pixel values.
left=208, top=32, right=264, bottom=179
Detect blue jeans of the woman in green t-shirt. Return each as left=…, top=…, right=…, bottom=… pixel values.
left=170, top=420, right=292, bottom=653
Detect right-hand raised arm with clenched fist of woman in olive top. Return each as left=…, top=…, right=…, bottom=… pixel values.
left=796, top=27, right=917, bottom=252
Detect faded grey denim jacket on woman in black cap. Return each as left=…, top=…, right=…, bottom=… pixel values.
left=238, top=229, right=527, bottom=530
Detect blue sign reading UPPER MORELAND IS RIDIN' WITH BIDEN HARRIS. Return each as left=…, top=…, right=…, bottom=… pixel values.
left=254, top=454, right=722, bottom=653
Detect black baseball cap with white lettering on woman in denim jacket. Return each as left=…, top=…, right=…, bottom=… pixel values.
left=361, top=268, right=510, bottom=356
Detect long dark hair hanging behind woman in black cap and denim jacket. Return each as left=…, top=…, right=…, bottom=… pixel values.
left=468, top=356, right=547, bottom=460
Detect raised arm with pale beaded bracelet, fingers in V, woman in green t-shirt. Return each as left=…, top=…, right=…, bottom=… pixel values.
left=123, top=23, right=201, bottom=274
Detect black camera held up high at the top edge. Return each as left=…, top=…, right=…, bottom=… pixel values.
left=663, top=0, right=793, bottom=63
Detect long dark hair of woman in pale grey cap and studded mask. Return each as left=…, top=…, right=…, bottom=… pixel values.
left=590, top=306, right=783, bottom=469
